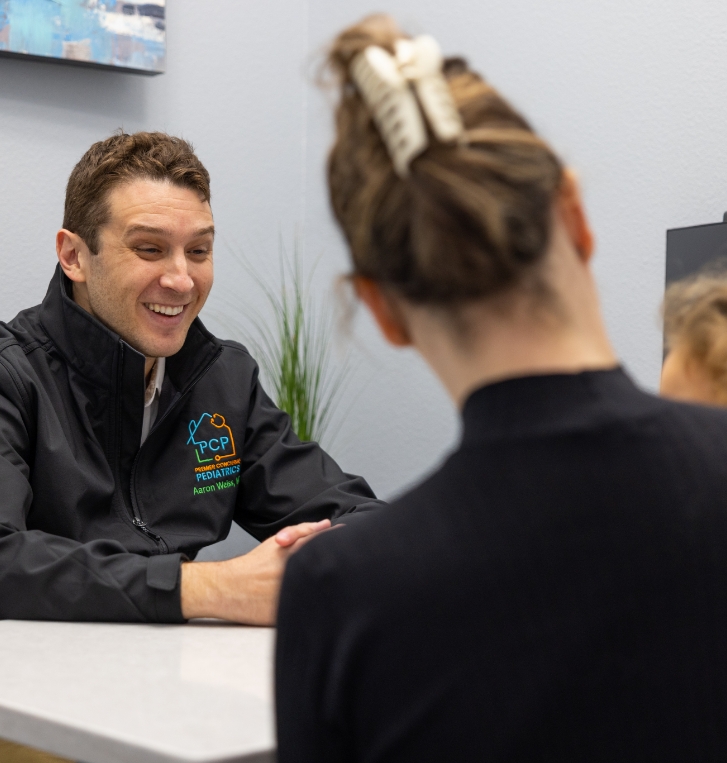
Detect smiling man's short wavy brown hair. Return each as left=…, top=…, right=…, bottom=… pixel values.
left=63, top=131, right=211, bottom=253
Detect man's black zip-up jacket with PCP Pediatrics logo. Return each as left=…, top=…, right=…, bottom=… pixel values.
left=0, top=268, right=381, bottom=622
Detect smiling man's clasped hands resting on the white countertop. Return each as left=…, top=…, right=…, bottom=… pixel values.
left=181, top=519, right=331, bottom=625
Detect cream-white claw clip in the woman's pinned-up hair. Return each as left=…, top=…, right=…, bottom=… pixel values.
left=351, top=35, right=464, bottom=177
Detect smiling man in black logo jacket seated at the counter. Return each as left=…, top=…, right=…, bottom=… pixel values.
left=0, top=133, right=380, bottom=624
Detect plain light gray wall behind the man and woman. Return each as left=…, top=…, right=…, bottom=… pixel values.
left=0, top=0, right=727, bottom=551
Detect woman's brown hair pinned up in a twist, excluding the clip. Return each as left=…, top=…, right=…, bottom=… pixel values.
left=327, top=15, right=563, bottom=307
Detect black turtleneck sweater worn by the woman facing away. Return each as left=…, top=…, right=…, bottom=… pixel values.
left=277, top=370, right=727, bottom=763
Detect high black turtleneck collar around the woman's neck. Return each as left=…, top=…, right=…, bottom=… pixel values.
left=462, top=367, right=648, bottom=445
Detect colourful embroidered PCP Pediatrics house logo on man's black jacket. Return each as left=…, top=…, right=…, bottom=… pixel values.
left=187, top=413, right=240, bottom=495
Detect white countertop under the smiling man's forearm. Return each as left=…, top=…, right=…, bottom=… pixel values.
left=0, top=620, right=275, bottom=763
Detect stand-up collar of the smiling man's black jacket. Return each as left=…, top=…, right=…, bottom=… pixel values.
left=40, top=265, right=220, bottom=391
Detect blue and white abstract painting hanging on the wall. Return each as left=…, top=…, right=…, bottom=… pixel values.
left=0, top=0, right=166, bottom=74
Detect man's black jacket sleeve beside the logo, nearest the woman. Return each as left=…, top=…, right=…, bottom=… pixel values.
left=235, top=366, right=386, bottom=540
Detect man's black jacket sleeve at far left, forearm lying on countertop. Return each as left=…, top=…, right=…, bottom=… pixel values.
left=0, top=358, right=183, bottom=622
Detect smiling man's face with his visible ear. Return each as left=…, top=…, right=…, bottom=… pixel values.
left=66, top=179, right=214, bottom=358
